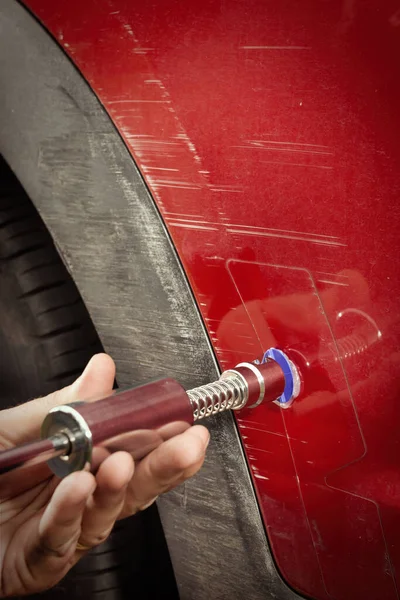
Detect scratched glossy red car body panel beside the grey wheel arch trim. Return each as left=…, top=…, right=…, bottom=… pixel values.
left=22, top=0, right=400, bottom=600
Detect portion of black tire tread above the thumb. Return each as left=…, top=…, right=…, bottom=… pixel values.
left=0, top=152, right=102, bottom=408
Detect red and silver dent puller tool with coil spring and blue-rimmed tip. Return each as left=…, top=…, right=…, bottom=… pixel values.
left=0, top=348, right=300, bottom=477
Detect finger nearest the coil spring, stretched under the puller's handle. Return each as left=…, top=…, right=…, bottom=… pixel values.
left=120, top=425, right=210, bottom=518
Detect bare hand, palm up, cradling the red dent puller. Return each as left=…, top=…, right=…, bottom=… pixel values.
left=0, top=354, right=209, bottom=598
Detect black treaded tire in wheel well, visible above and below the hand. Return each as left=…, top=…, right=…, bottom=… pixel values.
left=0, top=156, right=177, bottom=600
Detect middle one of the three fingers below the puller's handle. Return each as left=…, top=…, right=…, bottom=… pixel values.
left=79, top=452, right=134, bottom=548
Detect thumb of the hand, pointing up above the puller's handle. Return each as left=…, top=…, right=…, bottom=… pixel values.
left=0, top=354, right=115, bottom=445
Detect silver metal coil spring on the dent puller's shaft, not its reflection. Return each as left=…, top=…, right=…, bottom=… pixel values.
left=187, top=374, right=247, bottom=421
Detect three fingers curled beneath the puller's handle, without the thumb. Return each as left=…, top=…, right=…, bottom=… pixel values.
left=11, top=426, right=209, bottom=590
